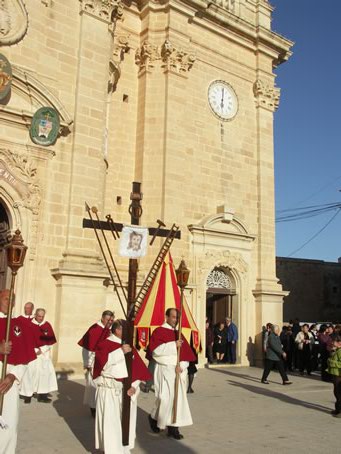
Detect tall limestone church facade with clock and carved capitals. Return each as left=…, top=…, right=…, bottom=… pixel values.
left=0, top=0, right=292, bottom=372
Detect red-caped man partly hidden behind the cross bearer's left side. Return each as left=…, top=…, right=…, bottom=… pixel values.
left=78, top=311, right=114, bottom=418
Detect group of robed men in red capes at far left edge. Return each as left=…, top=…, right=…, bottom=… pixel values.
left=0, top=290, right=58, bottom=454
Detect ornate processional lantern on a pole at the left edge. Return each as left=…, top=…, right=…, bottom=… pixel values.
left=0, top=229, right=27, bottom=418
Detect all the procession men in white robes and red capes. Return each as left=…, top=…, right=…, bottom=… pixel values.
left=0, top=290, right=197, bottom=454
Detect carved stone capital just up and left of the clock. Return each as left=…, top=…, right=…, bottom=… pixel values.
left=161, top=39, right=196, bottom=74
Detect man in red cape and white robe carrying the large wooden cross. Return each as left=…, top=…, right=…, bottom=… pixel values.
left=93, top=320, right=151, bottom=454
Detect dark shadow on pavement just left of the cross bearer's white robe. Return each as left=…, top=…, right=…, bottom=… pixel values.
left=53, top=380, right=96, bottom=452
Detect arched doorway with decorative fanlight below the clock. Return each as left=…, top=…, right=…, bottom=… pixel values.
left=206, top=268, right=236, bottom=325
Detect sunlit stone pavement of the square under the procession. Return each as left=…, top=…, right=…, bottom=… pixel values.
left=17, top=367, right=341, bottom=454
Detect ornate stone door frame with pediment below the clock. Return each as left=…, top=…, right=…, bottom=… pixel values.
left=188, top=208, right=255, bottom=365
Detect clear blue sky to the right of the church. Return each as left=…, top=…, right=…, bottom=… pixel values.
left=270, top=0, right=341, bottom=261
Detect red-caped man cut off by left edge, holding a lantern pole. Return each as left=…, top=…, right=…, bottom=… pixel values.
left=0, top=290, right=36, bottom=454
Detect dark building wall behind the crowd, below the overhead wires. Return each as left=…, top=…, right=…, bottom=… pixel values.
left=276, top=257, right=341, bottom=323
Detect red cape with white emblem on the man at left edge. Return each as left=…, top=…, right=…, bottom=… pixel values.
left=0, top=318, right=37, bottom=366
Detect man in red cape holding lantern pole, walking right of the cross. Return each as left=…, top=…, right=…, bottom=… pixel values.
left=148, top=308, right=196, bottom=440
